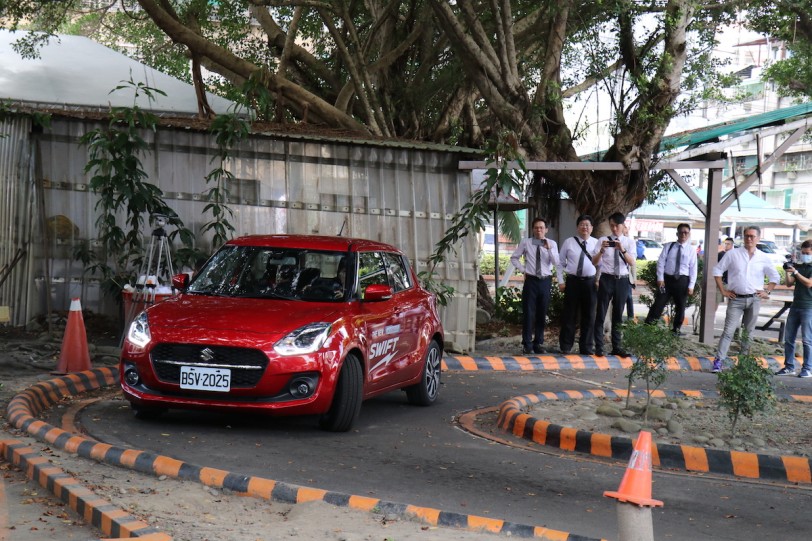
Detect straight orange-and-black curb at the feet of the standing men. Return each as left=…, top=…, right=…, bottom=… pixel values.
left=442, top=354, right=784, bottom=372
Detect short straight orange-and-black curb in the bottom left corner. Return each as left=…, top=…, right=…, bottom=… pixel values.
left=0, top=440, right=172, bottom=541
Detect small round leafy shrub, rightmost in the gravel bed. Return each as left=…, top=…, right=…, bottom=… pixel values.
left=716, top=342, right=776, bottom=434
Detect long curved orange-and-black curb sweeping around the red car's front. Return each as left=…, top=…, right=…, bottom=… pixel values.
left=8, top=368, right=597, bottom=541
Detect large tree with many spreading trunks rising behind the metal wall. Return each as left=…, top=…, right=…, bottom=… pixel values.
left=1, top=0, right=729, bottom=221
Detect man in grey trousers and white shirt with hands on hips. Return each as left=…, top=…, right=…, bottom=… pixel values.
left=712, top=225, right=780, bottom=372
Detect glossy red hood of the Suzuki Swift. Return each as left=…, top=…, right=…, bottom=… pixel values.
left=147, top=294, right=347, bottom=337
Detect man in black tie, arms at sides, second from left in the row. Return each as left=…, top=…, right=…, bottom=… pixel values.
left=558, top=214, right=598, bottom=355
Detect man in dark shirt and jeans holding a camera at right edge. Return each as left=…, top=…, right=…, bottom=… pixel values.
left=775, top=239, right=812, bottom=378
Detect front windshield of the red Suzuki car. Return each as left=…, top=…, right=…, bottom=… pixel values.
left=186, top=246, right=354, bottom=302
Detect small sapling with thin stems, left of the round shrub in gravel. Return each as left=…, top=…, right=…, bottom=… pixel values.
left=622, top=322, right=679, bottom=408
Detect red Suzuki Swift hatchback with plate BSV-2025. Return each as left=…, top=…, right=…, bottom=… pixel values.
left=120, top=235, right=443, bottom=431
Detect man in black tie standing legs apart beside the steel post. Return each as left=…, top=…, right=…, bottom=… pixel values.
left=646, top=224, right=697, bottom=335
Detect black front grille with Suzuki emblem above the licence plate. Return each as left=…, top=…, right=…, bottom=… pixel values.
left=150, top=344, right=268, bottom=388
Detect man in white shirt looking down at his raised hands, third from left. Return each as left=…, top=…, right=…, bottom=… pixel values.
left=592, top=212, right=637, bottom=357
